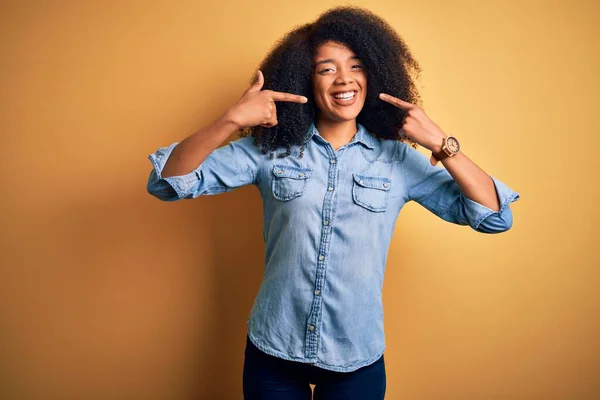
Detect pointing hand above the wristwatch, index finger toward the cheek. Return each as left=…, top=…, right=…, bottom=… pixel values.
left=379, top=93, right=447, bottom=153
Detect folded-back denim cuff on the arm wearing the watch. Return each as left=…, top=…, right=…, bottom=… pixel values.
left=462, top=176, right=519, bottom=233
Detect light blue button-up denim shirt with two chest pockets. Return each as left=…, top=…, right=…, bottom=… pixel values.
left=147, top=123, right=519, bottom=372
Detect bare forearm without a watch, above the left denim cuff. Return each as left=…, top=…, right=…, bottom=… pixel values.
left=162, top=113, right=238, bottom=178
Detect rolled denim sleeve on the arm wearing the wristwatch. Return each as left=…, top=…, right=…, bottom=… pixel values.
left=400, top=143, right=519, bottom=233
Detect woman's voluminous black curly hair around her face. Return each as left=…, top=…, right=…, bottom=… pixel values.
left=240, top=6, right=421, bottom=158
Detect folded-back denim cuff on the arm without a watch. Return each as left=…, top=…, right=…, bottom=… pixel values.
left=148, top=142, right=199, bottom=199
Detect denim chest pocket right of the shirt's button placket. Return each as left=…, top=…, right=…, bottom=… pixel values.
left=352, top=174, right=392, bottom=212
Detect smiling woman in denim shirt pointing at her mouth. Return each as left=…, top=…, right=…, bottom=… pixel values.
left=148, top=7, right=519, bottom=400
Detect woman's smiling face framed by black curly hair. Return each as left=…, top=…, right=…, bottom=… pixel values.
left=312, top=41, right=367, bottom=121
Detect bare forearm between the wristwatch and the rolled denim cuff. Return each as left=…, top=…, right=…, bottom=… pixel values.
left=442, top=152, right=500, bottom=211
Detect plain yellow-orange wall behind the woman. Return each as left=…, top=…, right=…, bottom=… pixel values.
left=0, top=0, right=600, bottom=400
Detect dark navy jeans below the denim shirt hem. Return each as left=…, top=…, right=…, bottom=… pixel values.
left=243, top=336, right=386, bottom=400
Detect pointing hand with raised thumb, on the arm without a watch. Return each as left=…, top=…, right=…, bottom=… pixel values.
left=226, top=70, right=308, bottom=129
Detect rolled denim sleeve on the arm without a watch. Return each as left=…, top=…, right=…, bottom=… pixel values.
left=147, top=136, right=261, bottom=201
